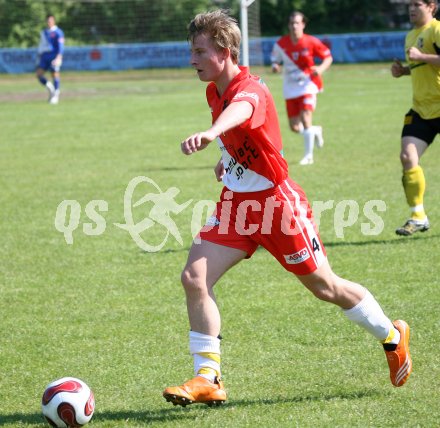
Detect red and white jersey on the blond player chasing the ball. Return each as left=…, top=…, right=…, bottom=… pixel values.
left=206, top=67, right=288, bottom=192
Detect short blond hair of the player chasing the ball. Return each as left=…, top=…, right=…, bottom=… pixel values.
left=188, top=9, right=241, bottom=64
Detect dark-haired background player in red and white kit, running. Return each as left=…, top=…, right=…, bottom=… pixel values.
left=271, top=12, right=333, bottom=165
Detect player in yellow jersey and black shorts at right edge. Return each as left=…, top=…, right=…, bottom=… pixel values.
left=391, top=0, right=440, bottom=236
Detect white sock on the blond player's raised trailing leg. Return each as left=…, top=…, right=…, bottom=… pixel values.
left=343, top=290, right=400, bottom=344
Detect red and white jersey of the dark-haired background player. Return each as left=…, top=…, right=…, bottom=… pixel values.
left=271, top=34, right=331, bottom=100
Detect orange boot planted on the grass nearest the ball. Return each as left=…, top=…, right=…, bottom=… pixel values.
left=163, top=376, right=226, bottom=407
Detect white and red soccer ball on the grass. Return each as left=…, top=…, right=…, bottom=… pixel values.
left=41, top=377, right=95, bottom=428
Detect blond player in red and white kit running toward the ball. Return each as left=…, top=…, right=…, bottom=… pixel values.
left=163, top=10, right=412, bottom=406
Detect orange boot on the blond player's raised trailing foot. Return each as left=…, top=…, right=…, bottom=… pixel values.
left=384, top=320, right=412, bottom=386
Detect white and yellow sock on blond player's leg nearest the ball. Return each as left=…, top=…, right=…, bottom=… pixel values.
left=189, top=331, right=220, bottom=382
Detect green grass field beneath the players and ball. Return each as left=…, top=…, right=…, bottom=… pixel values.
left=0, top=64, right=440, bottom=428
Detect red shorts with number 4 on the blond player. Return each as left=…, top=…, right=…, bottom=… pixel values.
left=198, top=179, right=326, bottom=275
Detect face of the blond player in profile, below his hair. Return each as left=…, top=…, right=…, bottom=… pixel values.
left=191, top=34, right=225, bottom=82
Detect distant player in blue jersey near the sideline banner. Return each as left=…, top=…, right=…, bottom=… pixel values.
left=36, top=14, right=64, bottom=104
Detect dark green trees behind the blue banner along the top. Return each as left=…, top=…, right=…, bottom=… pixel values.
left=0, top=0, right=408, bottom=47
